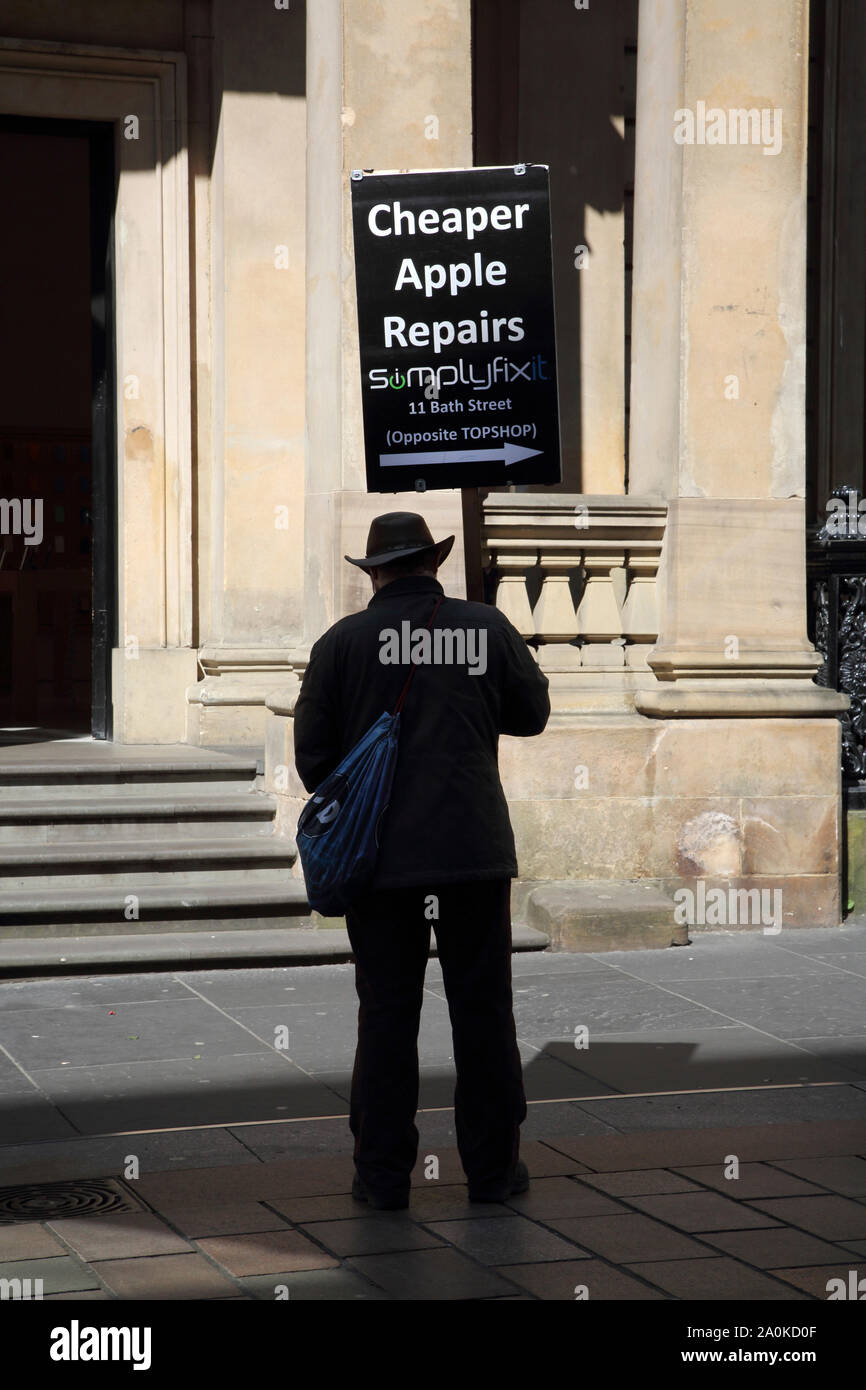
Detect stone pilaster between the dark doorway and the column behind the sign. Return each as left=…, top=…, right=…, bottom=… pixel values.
left=188, top=0, right=306, bottom=746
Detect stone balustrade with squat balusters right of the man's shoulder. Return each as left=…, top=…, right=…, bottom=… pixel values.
left=481, top=492, right=666, bottom=712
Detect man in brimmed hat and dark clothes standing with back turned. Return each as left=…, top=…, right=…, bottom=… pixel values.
left=295, top=512, right=550, bottom=1209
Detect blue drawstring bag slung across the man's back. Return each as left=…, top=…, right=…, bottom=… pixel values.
left=296, top=599, right=442, bottom=917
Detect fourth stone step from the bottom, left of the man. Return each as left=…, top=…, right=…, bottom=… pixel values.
left=0, top=790, right=275, bottom=849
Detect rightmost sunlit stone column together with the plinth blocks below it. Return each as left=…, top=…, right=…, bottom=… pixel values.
left=617, top=0, right=848, bottom=933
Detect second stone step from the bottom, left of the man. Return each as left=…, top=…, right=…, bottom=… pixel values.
left=0, top=874, right=313, bottom=940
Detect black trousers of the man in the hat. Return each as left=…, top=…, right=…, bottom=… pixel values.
left=346, top=878, right=527, bottom=1195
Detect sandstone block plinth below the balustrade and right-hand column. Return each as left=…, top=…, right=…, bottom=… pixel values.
left=499, top=714, right=841, bottom=937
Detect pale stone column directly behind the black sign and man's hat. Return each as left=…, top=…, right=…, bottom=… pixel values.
left=304, top=0, right=473, bottom=639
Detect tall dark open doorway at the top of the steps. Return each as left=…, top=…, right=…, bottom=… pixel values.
left=0, top=117, right=115, bottom=738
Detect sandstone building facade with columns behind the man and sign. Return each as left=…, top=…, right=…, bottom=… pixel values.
left=0, top=0, right=863, bottom=945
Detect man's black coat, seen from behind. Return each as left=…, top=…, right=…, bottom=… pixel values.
left=295, top=575, right=550, bottom=890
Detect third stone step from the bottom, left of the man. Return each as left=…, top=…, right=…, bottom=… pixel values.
left=0, top=835, right=297, bottom=889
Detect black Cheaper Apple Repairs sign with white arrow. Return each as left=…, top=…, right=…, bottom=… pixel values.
left=352, top=164, right=562, bottom=492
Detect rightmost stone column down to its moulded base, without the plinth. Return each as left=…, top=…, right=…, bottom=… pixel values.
left=630, top=0, right=847, bottom=717
